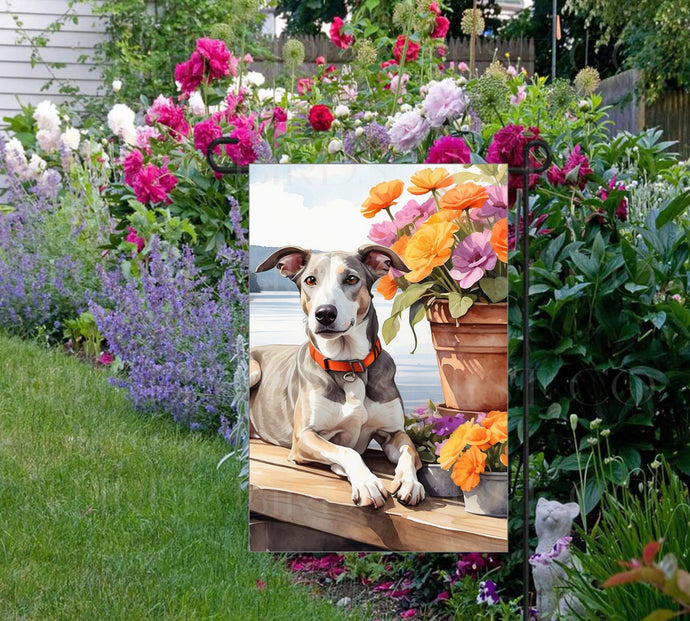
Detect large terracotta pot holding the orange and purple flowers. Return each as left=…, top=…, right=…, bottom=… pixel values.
left=427, top=300, right=508, bottom=412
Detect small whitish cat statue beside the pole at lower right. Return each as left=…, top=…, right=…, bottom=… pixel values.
left=529, top=498, right=584, bottom=621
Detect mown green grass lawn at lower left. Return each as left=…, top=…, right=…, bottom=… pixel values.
left=0, top=335, right=345, bottom=621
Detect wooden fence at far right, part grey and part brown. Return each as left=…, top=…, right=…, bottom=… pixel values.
left=599, top=69, right=690, bottom=158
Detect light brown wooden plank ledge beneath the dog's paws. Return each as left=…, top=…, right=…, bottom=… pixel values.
left=249, top=440, right=508, bottom=552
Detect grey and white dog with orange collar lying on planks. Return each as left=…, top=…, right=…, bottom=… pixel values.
left=249, top=245, right=424, bottom=508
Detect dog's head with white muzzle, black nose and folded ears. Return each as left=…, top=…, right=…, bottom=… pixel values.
left=256, top=244, right=409, bottom=339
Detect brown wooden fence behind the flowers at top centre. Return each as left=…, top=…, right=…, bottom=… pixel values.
left=252, top=35, right=534, bottom=82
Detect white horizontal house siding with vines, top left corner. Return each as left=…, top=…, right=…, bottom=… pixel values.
left=0, top=0, right=105, bottom=125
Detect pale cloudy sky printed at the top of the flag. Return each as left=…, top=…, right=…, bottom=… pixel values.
left=249, top=164, right=500, bottom=252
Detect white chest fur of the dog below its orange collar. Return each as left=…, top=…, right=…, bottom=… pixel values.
left=309, top=378, right=405, bottom=453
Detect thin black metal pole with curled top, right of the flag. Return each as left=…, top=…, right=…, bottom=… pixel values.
left=508, top=139, right=552, bottom=621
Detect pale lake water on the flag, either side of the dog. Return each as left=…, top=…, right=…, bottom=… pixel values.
left=249, top=291, right=443, bottom=413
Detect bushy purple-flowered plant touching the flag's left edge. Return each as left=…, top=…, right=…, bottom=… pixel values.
left=90, top=238, right=247, bottom=431
